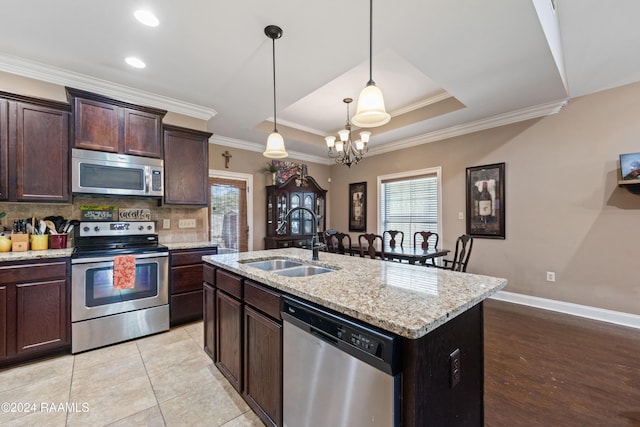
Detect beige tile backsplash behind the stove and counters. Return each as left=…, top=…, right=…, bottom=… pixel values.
left=0, top=196, right=209, bottom=243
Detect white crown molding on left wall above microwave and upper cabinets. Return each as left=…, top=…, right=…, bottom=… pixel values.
left=0, top=54, right=218, bottom=121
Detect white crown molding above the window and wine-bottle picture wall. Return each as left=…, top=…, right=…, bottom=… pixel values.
left=369, top=99, right=569, bottom=156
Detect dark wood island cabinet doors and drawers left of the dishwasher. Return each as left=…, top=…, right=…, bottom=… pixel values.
left=203, top=265, right=282, bottom=426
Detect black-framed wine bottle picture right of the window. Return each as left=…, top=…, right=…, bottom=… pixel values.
left=467, top=163, right=505, bottom=239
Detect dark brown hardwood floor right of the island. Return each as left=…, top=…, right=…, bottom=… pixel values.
left=484, top=300, right=640, bottom=427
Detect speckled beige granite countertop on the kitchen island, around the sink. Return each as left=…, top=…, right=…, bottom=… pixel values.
left=203, top=249, right=507, bottom=339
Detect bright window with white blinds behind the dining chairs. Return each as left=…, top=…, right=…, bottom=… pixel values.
left=380, top=173, right=440, bottom=247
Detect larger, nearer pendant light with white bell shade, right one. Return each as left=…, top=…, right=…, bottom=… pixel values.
left=351, top=0, right=391, bottom=128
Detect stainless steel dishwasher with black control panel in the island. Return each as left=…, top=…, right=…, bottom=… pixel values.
left=282, top=297, right=401, bottom=427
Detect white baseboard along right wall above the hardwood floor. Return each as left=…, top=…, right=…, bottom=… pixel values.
left=491, top=291, right=640, bottom=329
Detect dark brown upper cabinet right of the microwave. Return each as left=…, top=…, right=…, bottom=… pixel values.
left=163, top=125, right=212, bottom=206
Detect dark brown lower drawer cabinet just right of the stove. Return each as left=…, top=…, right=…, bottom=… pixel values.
left=169, top=247, right=218, bottom=326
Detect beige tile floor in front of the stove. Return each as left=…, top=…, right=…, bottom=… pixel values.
left=0, top=322, right=263, bottom=427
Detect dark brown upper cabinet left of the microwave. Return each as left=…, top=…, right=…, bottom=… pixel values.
left=0, top=92, right=71, bottom=202
